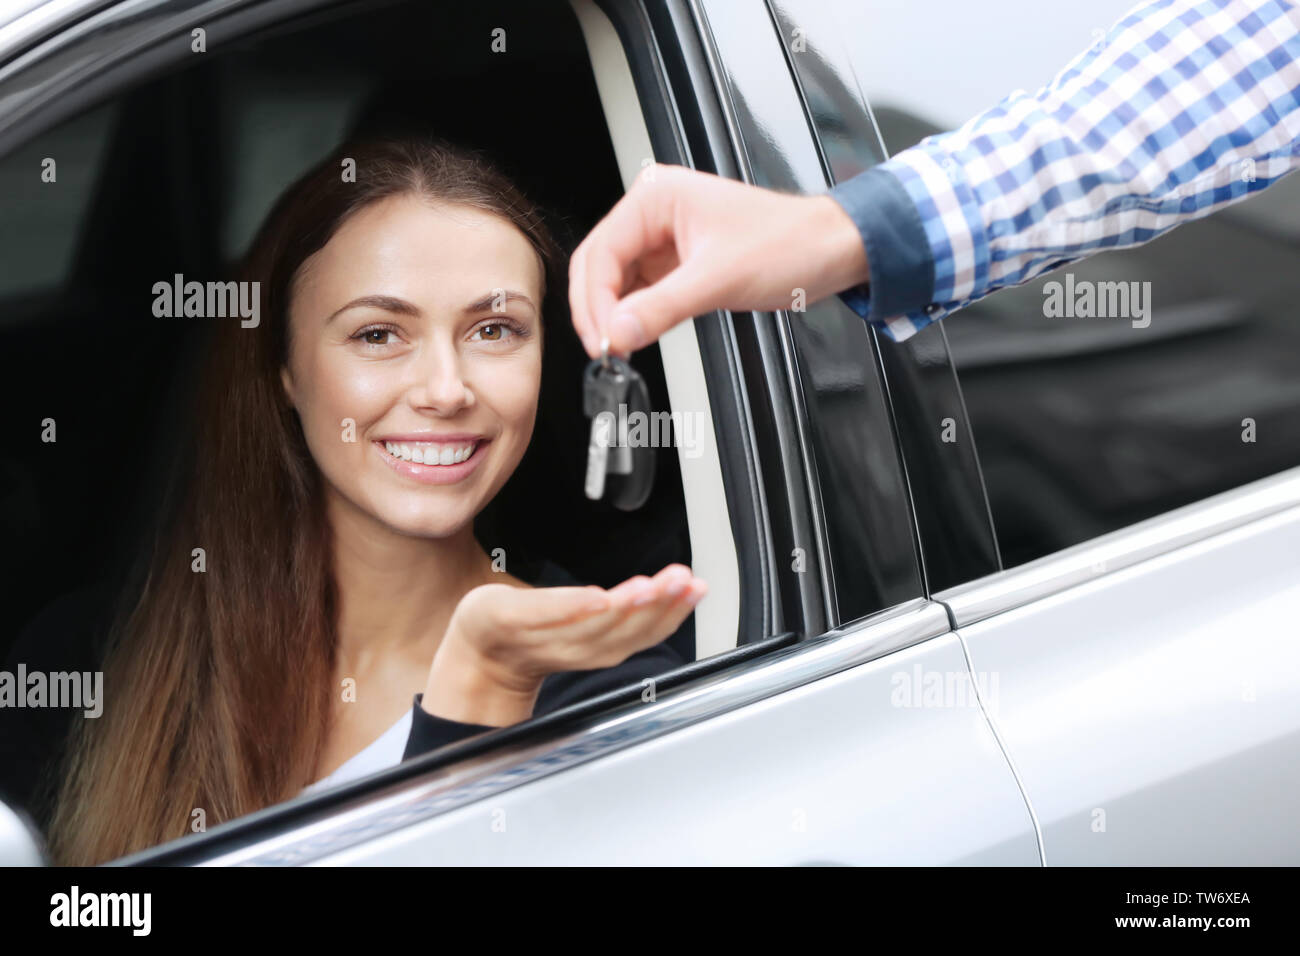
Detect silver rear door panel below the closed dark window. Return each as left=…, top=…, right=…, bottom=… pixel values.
left=940, top=489, right=1300, bottom=865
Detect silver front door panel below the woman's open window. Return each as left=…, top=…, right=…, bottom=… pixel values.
left=317, top=605, right=1039, bottom=865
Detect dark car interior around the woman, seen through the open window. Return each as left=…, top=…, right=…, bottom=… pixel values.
left=0, top=3, right=744, bottom=661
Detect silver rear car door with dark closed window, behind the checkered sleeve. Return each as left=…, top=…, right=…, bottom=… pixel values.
left=845, top=0, right=1300, bottom=865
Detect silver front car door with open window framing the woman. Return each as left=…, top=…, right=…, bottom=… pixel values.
left=0, top=0, right=1039, bottom=865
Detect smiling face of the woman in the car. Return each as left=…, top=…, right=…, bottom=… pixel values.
left=283, top=195, right=542, bottom=537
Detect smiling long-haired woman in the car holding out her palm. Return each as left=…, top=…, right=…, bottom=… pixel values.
left=32, top=140, right=705, bottom=864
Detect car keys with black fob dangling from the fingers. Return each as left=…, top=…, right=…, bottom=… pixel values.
left=582, top=355, right=655, bottom=511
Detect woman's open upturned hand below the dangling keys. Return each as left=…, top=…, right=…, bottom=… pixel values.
left=421, top=564, right=707, bottom=727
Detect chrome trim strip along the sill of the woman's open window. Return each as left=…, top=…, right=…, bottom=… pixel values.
left=122, top=598, right=949, bottom=866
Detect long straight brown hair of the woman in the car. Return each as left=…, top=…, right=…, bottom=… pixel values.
left=49, top=139, right=563, bottom=865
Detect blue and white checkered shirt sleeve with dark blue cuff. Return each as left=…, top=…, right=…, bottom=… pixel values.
left=828, top=0, right=1300, bottom=341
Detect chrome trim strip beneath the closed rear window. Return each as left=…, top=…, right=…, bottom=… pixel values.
left=933, top=468, right=1300, bottom=627
